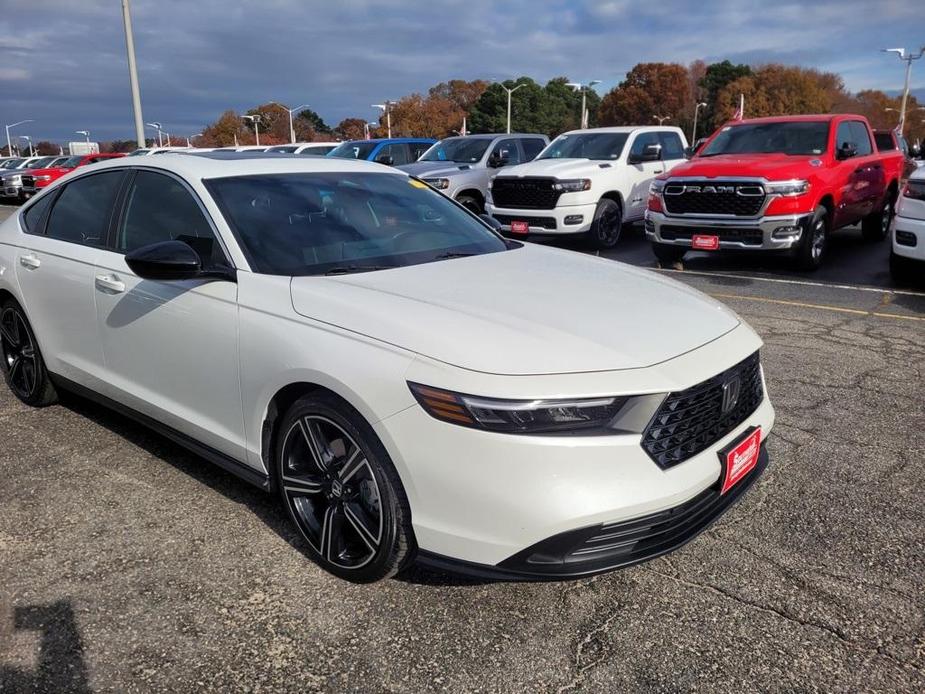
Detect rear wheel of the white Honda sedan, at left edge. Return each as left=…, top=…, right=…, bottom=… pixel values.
left=0, top=299, right=58, bottom=407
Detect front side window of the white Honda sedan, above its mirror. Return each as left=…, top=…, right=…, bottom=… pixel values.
left=116, top=171, right=227, bottom=270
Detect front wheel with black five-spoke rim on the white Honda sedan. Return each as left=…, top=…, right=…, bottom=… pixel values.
left=275, top=392, right=414, bottom=583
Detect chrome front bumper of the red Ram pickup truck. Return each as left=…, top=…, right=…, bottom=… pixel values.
left=645, top=210, right=812, bottom=251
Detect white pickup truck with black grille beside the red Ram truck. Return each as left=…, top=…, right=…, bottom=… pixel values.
left=486, top=126, right=687, bottom=248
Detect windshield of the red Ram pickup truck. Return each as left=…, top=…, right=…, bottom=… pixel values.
left=697, top=121, right=829, bottom=157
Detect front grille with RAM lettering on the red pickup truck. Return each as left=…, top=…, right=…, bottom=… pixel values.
left=663, top=180, right=765, bottom=217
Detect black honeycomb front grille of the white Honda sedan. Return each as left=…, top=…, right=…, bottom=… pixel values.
left=642, top=352, right=764, bottom=468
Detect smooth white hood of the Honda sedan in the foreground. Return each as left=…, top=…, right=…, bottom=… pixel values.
left=291, top=244, right=739, bottom=375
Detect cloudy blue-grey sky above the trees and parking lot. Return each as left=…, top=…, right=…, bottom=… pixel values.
left=0, top=0, right=925, bottom=141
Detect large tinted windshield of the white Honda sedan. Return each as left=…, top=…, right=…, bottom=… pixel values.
left=206, top=172, right=509, bottom=276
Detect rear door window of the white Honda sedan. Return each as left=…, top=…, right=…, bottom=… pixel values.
left=45, top=171, right=122, bottom=246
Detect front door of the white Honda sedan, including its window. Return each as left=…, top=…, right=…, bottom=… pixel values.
left=93, top=169, right=246, bottom=461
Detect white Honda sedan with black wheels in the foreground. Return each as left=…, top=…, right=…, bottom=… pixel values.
left=0, top=153, right=774, bottom=582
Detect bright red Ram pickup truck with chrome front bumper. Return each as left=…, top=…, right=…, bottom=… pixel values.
left=645, top=114, right=903, bottom=270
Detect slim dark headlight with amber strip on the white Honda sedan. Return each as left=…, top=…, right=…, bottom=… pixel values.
left=408, top=382, right=629, bottom=434
